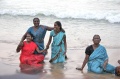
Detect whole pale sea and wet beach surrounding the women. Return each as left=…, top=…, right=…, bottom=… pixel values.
left=0, top=0, right=120, bottom=79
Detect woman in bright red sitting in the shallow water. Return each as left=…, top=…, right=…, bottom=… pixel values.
left=16, top=33, right=44, bottom=66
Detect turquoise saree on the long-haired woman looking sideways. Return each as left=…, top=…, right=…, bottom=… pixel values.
left=50, top=30, right=65, bottom=63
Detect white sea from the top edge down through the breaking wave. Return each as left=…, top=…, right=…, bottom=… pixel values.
left=0, top=0, right=120, bottom=23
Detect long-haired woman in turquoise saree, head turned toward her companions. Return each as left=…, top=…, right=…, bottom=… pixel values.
left=46, top=21, right=67, bottom=63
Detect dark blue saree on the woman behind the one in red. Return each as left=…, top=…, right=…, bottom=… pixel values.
left=27, top=25, right=47, bottom=54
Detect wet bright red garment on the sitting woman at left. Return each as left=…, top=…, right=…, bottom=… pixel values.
left=20, top=41, right=44, bottom=66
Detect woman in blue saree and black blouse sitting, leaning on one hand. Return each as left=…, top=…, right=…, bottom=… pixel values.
left=76, top=35, right=115, bottom=74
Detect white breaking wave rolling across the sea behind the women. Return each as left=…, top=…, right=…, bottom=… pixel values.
left=0, top=9, right=120, bottom=23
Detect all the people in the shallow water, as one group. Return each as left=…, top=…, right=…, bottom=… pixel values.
left=16, top=18, right=120, bottom=76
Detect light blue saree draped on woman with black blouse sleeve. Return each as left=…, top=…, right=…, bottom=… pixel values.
left=88, top=45, right=115, bottom=73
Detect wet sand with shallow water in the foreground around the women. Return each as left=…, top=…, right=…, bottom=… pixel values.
left=0, top=43, right=120, bottom=79
